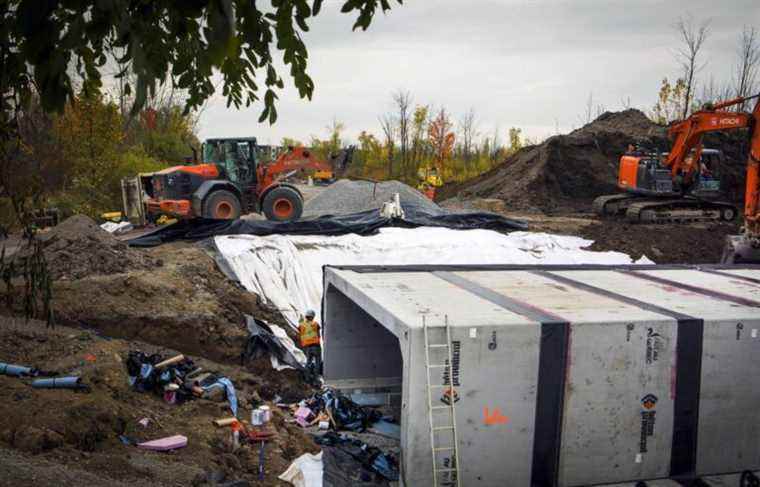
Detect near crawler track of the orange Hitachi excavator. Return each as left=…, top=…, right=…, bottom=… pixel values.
left=625, top=198, right=737, bottom=223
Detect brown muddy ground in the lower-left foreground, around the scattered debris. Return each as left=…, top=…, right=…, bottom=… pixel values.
left=0, top=319, right=319, bottom=486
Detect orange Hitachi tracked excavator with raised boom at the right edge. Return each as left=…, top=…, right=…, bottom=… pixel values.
left=594, top=94, right=760, bottom=262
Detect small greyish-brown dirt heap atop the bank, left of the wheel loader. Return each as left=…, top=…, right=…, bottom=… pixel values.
left=40, top=215, right=160, bottom=280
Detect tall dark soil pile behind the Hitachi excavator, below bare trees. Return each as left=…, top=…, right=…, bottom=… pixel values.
left=439, top=109, right=667, bottom=212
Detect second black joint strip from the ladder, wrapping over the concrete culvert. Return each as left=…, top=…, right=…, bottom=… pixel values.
left=533, top=271, right=704, bottom=478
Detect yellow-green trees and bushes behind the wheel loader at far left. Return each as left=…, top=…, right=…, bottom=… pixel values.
left=0, top=89, right=199, bottom=224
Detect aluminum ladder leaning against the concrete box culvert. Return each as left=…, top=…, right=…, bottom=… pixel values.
left=422, top=315, right=460, bottom=487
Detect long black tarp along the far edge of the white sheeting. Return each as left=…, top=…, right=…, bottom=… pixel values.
left=128, top=205, right=528, bottom=247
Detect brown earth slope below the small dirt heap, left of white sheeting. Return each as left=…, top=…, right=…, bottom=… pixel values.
left=46, top=243, right=284, bottom=363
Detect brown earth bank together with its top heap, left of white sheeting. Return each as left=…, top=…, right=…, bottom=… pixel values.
left=8, top=216, right=294, bottom=363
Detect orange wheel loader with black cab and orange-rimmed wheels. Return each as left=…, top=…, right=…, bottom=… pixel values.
left=140, top=137, right=353, bottom=221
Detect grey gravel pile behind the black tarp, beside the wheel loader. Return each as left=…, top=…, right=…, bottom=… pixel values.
left=304, top=179, right=441, bottom=217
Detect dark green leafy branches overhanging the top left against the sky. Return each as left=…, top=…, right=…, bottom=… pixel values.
left=0, top=0, right=401, bottom=122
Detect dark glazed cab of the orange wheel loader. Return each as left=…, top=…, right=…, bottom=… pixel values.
left=202, top=137, right=258, bottom=187
